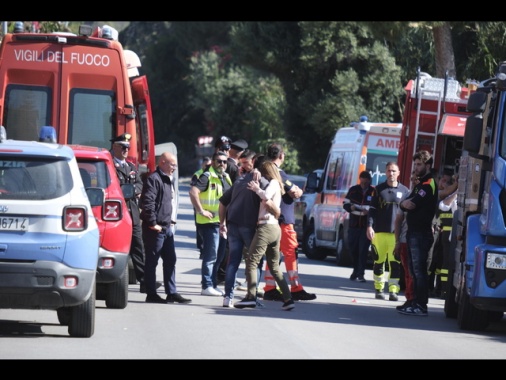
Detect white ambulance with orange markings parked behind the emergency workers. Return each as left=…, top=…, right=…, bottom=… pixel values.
left=302, top=116, right=402, bottom=266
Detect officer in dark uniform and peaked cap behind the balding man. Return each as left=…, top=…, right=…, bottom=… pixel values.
left=110, top=133, right=161, bottom=293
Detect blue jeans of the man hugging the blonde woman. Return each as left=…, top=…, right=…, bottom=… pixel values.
left=225, top=223, right=261, bottom=299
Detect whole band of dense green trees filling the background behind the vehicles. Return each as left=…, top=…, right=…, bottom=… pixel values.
left=20, top=21, right=506, bottom=175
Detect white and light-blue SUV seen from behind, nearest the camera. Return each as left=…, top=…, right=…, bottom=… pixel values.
left=0, top=127, right=103, bottom=337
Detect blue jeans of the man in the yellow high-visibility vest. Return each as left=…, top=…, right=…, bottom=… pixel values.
left=198, top=223, right=219, bottom=289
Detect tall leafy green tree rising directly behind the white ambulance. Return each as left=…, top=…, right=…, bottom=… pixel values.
left=278, top=22, right=403, bottom=172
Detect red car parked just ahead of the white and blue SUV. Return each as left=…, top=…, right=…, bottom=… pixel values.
left=69, top=145, right=135, bottom=309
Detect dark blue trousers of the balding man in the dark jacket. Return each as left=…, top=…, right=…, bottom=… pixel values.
left=142, top=223, right=177, bottom=294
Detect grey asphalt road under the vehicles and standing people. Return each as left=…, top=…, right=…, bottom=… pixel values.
left=0, top=178, right=506, bottom=360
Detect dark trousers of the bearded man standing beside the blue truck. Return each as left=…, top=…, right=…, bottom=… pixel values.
left=406, top=227, right=434, bottom=308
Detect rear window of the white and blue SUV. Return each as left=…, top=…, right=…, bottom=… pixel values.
left=0, top=156, right=74, bottom=200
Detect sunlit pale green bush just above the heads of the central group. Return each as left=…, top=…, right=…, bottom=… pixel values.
left=187, top=48, right=286, bottom=163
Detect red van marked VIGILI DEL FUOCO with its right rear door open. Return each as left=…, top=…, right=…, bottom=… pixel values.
left=0, top=25, right=156, bottom=173
